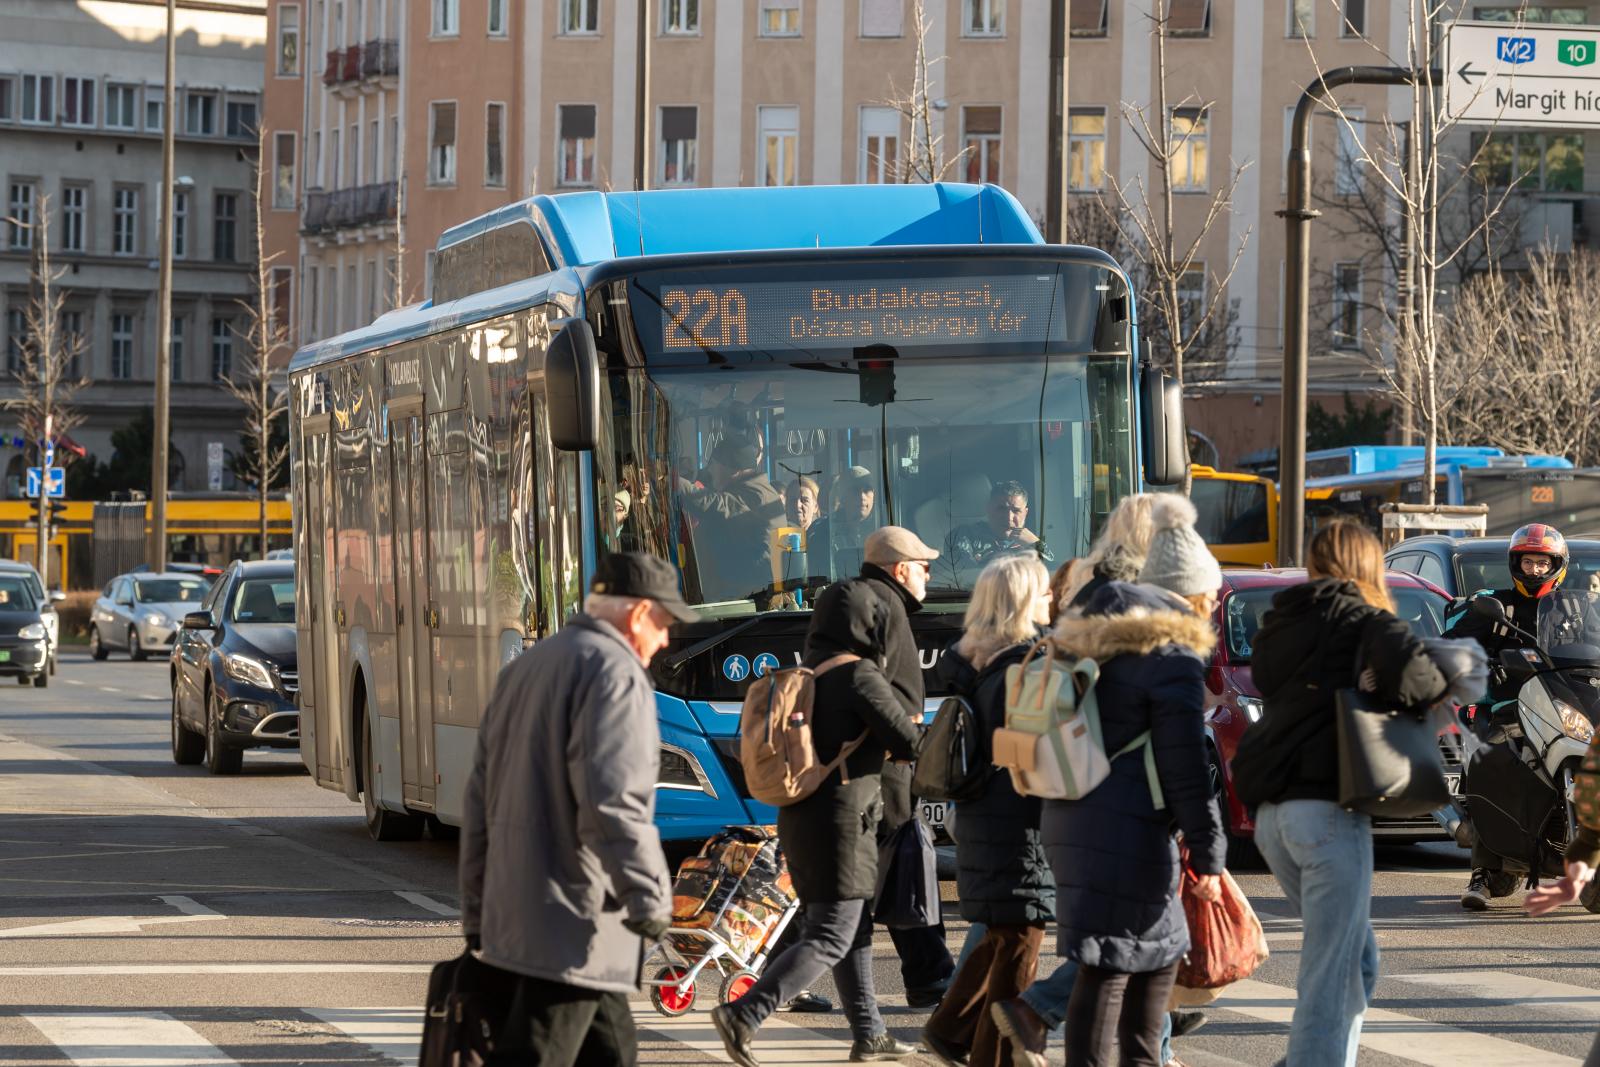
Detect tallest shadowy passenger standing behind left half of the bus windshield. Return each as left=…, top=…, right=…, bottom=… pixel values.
left=680, top=437, right=784, bottom=603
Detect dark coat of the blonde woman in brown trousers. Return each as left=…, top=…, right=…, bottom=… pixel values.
left=938, top=641, right=1056, bottom=926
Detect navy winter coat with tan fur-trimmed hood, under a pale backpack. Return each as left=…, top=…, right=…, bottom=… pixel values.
left=1040, top=582, right=1226, bottom=974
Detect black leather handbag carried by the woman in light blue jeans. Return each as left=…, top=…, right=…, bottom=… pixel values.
left=1334, top=689, right=1450, bottom=819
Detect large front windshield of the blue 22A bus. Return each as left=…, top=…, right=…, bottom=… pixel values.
left=597, top=257, right=1134, bottom=617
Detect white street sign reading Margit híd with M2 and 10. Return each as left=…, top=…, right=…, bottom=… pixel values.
left=1443, top=22, right=1600, bottom=130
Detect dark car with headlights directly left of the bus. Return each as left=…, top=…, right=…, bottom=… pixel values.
left=171, top=561, right=299, bottom=774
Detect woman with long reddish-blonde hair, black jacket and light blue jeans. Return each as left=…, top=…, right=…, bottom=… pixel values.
left=1234, top=522, right=1446, bottom=1067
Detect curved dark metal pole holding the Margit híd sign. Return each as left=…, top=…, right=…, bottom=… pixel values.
left=1278, top=67, right=1443, bottom=566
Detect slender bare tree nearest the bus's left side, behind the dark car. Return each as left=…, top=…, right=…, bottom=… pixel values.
left=218, top=135, right=290, bottom=558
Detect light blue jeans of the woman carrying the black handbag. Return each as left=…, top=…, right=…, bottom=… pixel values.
left=1256, top=800, right=1378, bottom=1067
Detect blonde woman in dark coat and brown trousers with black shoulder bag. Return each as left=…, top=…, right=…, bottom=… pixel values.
left=923, top=555, right=1054, bottom=1067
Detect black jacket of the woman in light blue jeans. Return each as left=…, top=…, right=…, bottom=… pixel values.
left=1234, top=577, right=1446, bottom=805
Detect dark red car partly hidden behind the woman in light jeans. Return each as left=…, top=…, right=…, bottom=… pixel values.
left=1205, top=569, right=1462, bottom=865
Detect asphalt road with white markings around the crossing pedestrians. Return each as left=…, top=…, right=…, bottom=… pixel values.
left=0, top=653, right=1600, bottom=1067
